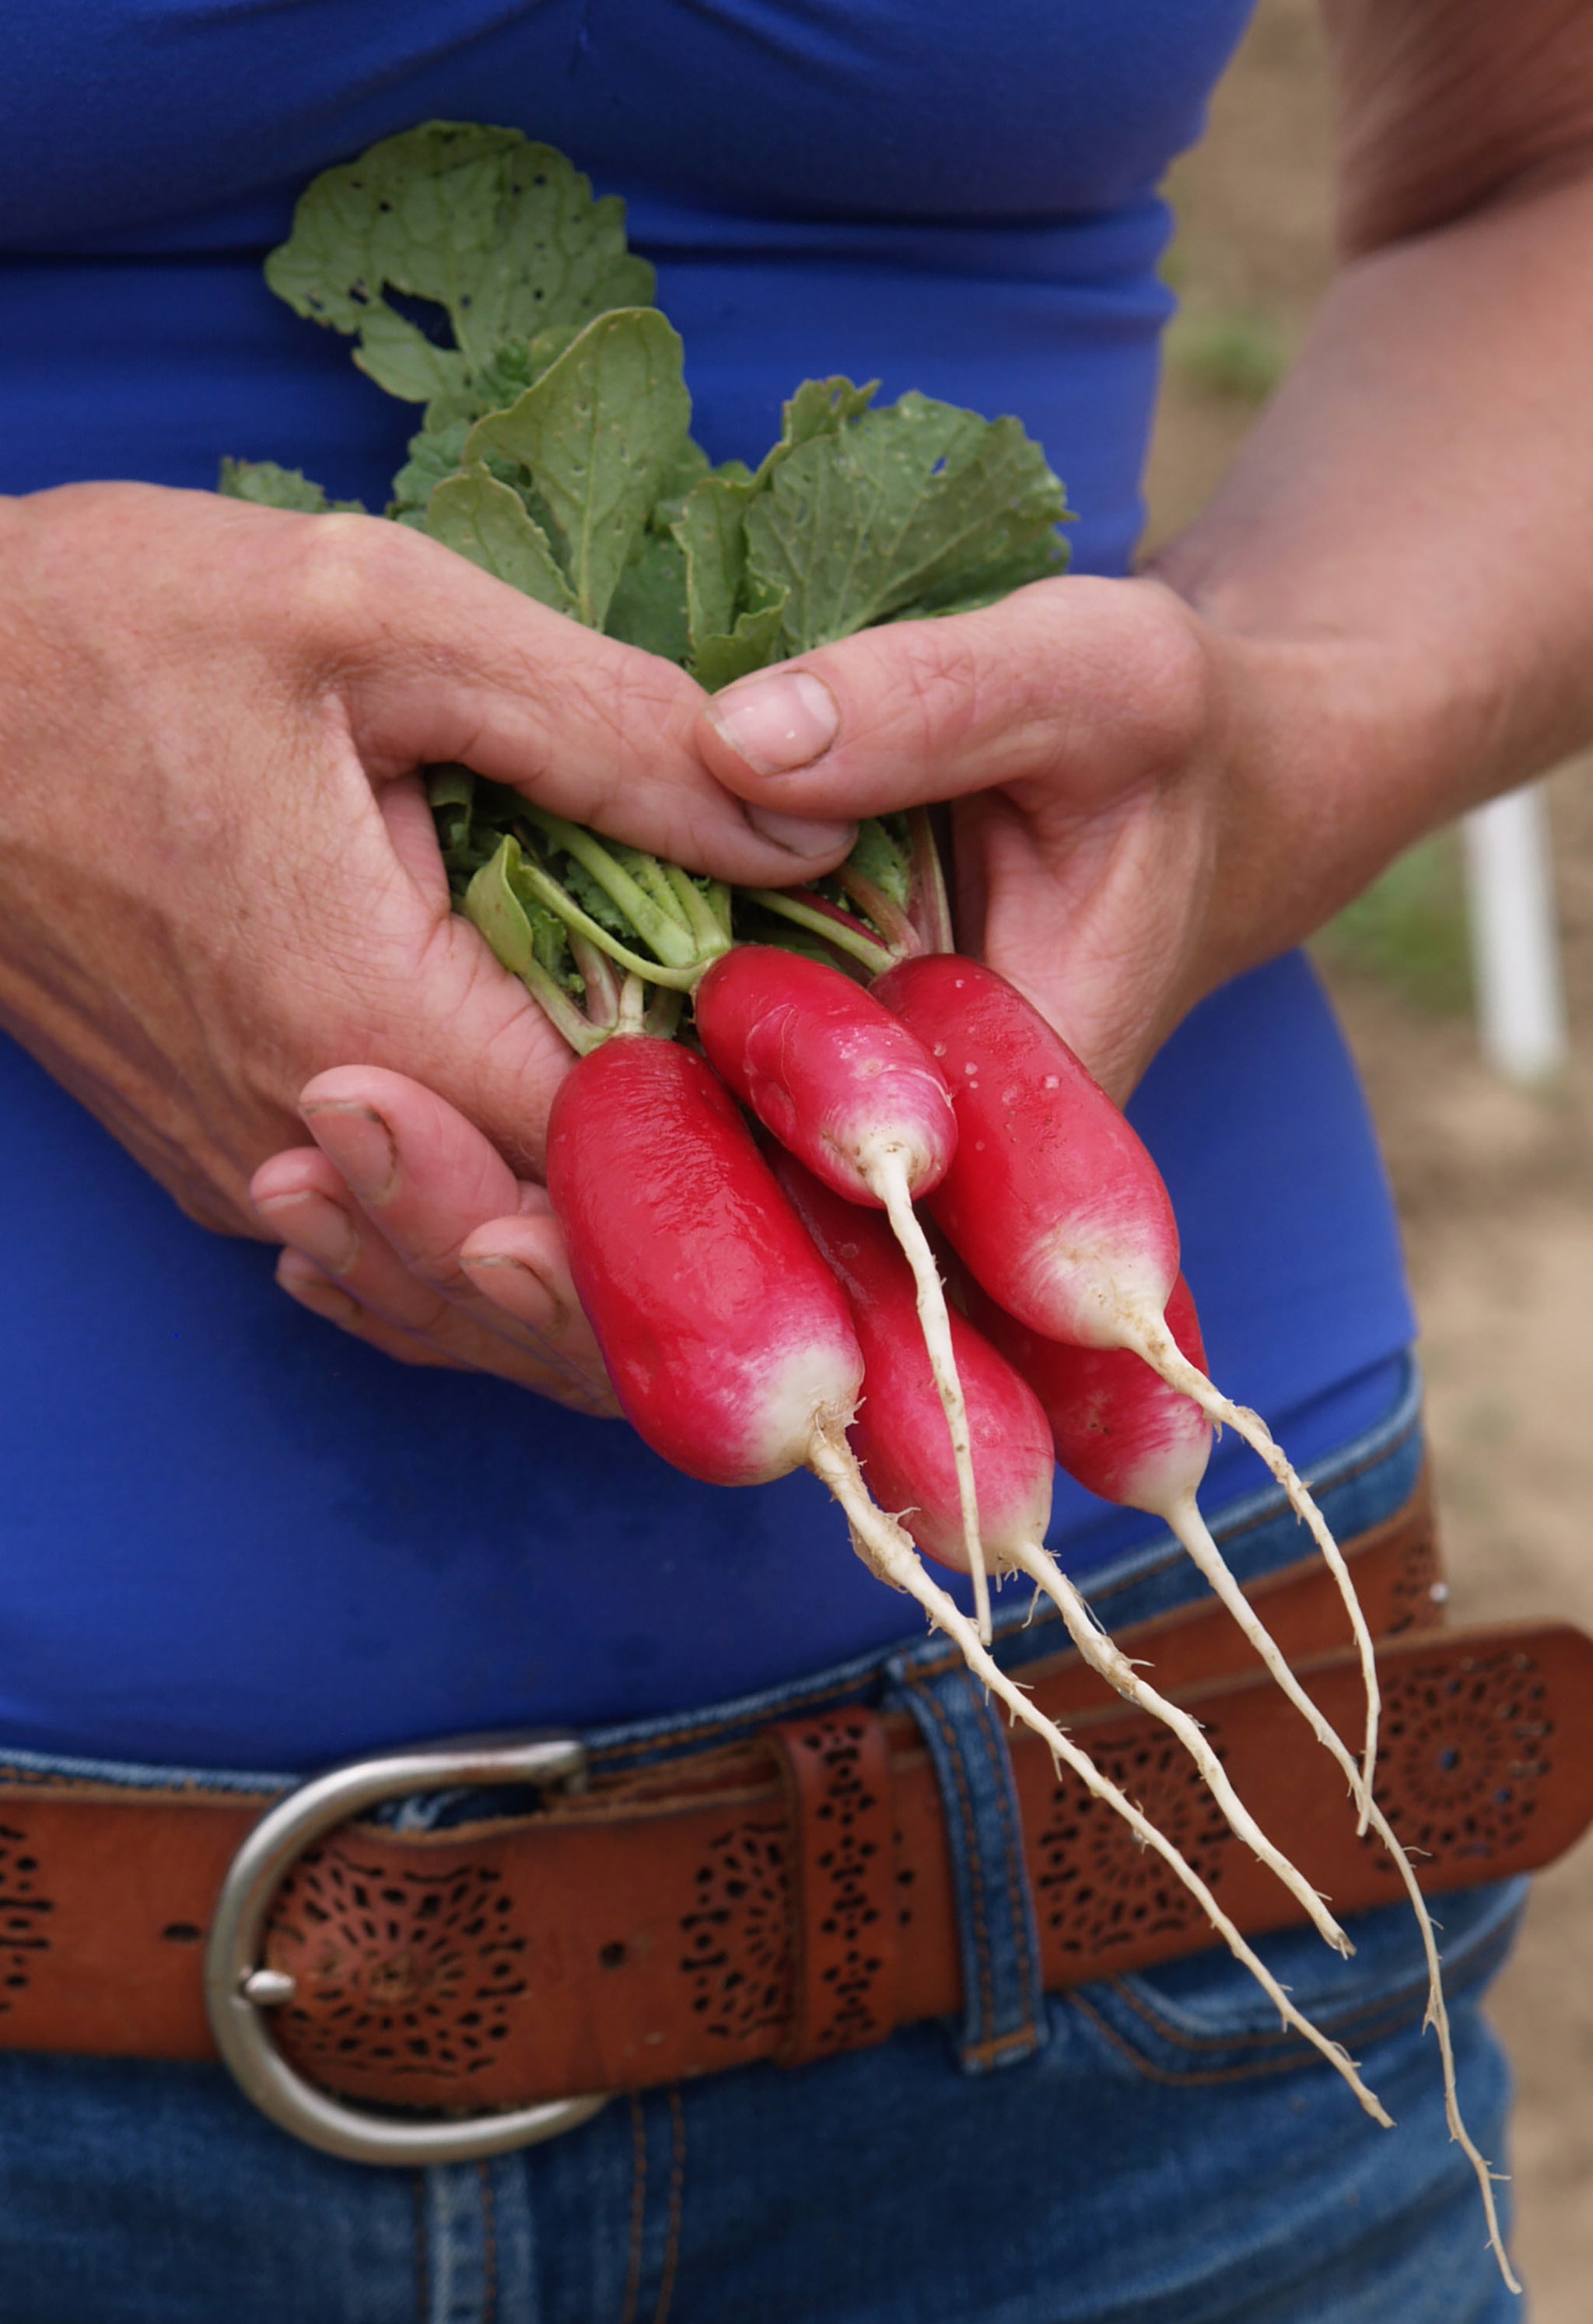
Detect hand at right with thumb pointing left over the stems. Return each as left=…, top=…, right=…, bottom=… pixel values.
left=698, top=579, right=1332, bottom=1099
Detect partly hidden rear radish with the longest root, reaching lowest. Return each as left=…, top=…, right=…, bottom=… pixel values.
left=976, top=1273, right=1521, bottom=2289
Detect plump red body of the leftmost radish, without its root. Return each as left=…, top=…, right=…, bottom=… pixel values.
left=547, top=1034, right=863, bottom=1485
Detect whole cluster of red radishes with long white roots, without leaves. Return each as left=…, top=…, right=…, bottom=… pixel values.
left=534, top=946, right=1504, bottom=2266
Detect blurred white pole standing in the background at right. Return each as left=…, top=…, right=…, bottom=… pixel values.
left=1463, top=783, right=1567, bottom=1085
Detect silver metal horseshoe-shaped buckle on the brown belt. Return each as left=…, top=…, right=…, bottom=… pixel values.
left=205, top=1734, right=609, bottom=2166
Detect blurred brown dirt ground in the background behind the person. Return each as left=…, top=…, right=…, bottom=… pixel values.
left=1151, top=0, right=1593, bottom=2324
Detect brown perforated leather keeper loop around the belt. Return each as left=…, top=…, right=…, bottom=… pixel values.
left=770, top=1710, right=900, bottom=2066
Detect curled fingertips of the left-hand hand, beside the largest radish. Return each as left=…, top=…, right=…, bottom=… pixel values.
left=251, top=1066, right=618, bottom=1416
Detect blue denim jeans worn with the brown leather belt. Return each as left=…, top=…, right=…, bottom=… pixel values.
left=0, top=1378, right=1521, bottom=2324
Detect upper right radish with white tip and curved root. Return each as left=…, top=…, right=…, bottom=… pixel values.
left=874, top=955, right=1379, bottom=1803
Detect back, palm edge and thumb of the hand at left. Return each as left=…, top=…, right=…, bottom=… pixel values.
left=0, top=484, right=851, bottom=1234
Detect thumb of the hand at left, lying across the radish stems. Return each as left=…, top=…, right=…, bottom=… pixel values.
left=293, top=516, right=853, bottom=885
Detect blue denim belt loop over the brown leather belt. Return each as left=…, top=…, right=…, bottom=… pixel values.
left=886, top=1654, right=1051, bottom=2073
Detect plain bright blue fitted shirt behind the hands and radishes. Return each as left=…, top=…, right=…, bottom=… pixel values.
left=0, top=0, right=1412, bottom=1766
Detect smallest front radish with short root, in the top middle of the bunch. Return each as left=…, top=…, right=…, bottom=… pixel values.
left=693, top=943, right=991, bottom=1646
